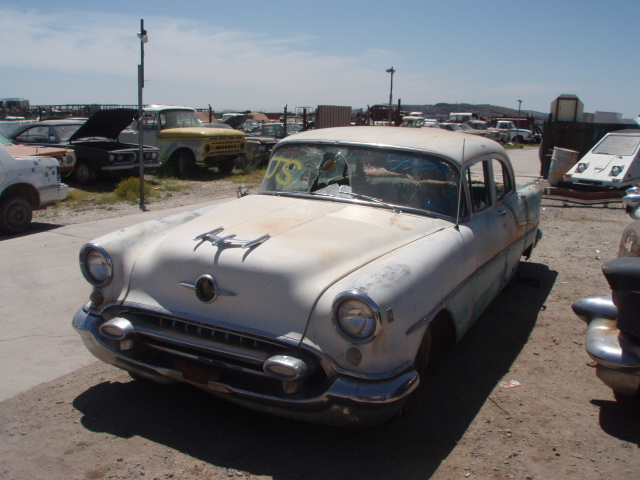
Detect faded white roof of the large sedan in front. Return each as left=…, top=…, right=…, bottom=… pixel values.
left=279, top=126, right=508, bottom=164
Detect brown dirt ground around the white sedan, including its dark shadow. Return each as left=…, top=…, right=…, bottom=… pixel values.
left=0, top=185, right=640, bottom=480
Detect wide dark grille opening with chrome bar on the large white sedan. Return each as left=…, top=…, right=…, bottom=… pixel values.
left=103, top=309, right=333, bottom=398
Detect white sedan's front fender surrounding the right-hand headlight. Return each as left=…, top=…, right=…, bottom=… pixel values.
left=303, top=223, right=475, bottom=378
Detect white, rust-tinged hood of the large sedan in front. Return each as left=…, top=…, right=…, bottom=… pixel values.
left=125, top=195, right=453, bottom=341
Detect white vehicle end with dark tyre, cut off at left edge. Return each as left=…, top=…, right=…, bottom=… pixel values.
left=0, top=145, right=69, bottom=235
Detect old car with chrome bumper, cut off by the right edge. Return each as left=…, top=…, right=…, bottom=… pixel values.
left=572, top=187, right=640, bottom=399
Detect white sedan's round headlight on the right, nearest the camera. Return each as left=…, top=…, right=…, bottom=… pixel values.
left=333, top=291, right=380, bottom=342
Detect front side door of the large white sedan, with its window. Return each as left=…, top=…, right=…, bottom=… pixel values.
left=465, top=156, right=514, bottom=316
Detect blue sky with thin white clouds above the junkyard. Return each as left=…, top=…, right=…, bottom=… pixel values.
left=0, top=0, right=640, bottom=118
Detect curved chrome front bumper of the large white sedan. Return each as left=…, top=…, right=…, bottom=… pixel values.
left=72, top=307, right=419, bottom=427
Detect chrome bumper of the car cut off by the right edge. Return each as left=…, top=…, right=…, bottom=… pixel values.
left=572, top=296, right=640, bottom=395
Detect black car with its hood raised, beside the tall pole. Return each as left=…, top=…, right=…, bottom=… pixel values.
left=12, top=108, right=160, bottom=185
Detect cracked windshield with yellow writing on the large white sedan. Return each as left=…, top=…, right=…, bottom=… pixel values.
left=259, top=143, right=466, bottom=218
